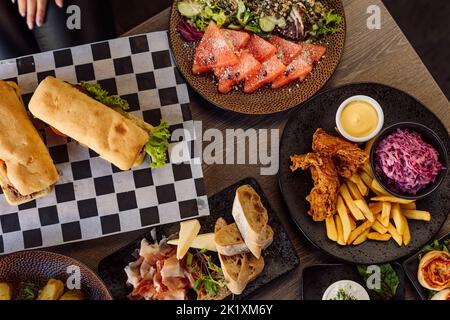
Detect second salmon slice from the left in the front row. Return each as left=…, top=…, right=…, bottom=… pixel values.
left=214, top=51, right=261, bottom=93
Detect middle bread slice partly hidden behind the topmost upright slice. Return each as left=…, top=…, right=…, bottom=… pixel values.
left=214, top=223, right=273, bottom=256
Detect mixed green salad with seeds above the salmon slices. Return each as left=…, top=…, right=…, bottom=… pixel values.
left=177, top=0, right=343, bottom=42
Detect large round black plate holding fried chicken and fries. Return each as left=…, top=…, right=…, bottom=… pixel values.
left=279, top=83, right=450, bottom=264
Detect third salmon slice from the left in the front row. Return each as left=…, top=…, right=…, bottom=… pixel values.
left=244, top=55, right=286, bottom=93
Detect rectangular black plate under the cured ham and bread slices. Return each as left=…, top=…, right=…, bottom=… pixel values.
left=98, top=178, right=300, bottom=300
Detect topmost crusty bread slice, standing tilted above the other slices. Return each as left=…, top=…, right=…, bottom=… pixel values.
left=232, top=185, right=269, bottom=258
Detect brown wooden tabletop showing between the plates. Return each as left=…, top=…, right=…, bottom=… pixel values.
left=51, top=0, right=450, bottom=299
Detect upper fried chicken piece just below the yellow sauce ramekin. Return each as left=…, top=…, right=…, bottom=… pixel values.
left=312, top=128, right=369, bottom=179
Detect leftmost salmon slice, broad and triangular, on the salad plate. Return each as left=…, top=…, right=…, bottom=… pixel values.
left=192, top=21, right=239, bottom=74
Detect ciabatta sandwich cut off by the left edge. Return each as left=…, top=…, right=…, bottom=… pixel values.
left=0, top=81, right=59, bottom=205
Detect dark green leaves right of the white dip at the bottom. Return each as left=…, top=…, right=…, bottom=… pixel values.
left=357, top=263, right=400, bottom=300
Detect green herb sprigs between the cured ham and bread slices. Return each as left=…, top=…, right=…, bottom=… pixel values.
left=186, top=249, right=226, bottom=297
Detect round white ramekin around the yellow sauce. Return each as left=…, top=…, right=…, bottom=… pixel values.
left=336, top=95, right=384, bottom=143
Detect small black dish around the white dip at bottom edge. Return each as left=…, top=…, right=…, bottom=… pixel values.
left=302, top=262, right=405, bottom=300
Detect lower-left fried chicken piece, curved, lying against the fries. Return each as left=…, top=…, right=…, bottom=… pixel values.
left=291, top=153, right=340, bottom=221
